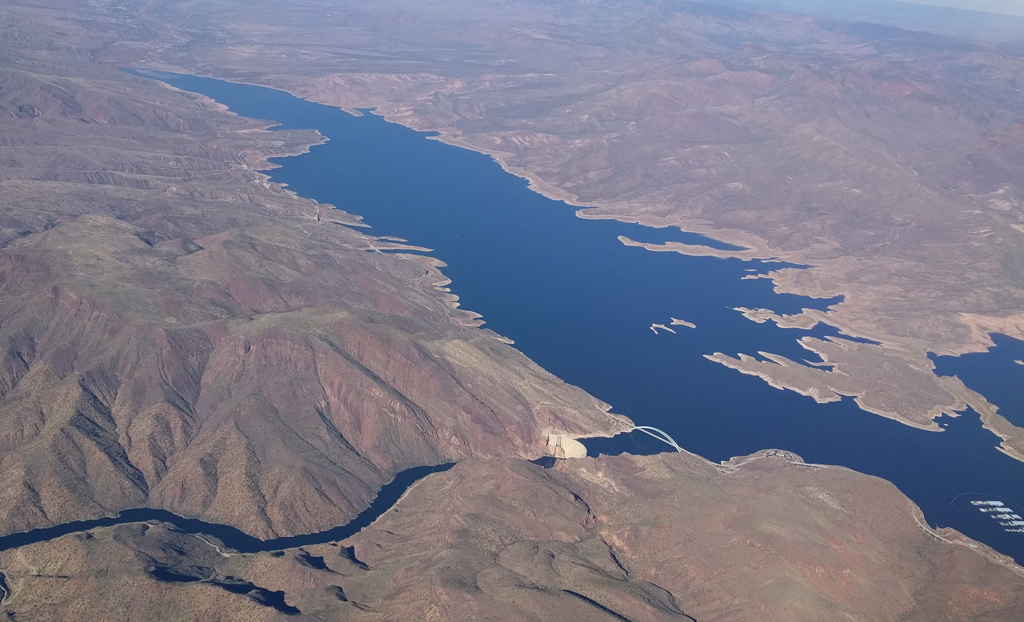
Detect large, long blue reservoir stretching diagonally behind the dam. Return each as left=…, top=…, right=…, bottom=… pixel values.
left=136, top=74, right=1024, bottom=562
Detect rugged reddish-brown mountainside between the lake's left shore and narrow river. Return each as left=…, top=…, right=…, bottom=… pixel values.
left=0, top=65, right=624, bottom=536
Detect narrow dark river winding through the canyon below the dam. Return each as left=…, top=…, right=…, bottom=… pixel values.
left=0, top=462, right=455, bottom=553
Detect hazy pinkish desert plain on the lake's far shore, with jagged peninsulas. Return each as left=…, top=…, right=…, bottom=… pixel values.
left=66, top=0, right=1024, bottom=456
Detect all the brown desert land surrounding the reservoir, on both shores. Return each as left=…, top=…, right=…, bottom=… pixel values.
left=0, top=0, right=1024, bottom=622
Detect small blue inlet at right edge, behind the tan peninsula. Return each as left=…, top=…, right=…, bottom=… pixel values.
left=932, top=334, right=1024, bottom=426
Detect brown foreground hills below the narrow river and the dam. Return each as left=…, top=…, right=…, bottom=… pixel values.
left=0, top=452, right=1024, bottom=622
